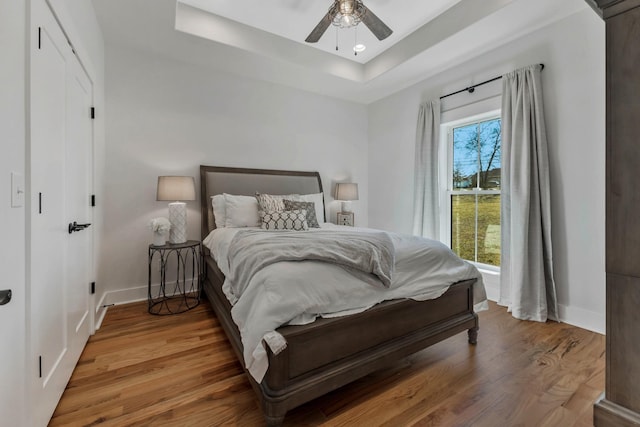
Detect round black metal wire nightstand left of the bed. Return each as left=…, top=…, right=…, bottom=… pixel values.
left=147, top=240, right=202, bottom=315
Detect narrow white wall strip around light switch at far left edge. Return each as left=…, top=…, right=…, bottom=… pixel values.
left=0, top=1, right=27, bottom=426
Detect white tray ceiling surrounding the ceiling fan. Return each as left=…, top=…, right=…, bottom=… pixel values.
left=92, top=0, right=588, bottom=104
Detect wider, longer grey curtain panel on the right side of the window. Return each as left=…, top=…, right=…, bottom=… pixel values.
left=499, top=65, right=558, bottom=322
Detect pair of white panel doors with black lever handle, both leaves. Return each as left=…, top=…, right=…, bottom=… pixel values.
left=28, top=1, right=93, bottom=426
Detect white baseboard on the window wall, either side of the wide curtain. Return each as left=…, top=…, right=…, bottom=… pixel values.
left=480, top=270, right=606, bottom=335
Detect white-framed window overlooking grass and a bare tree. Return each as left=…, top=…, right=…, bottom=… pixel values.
left=442, top=112, right=502, bottom=269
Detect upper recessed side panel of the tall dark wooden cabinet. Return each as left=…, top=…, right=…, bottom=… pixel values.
left=607, top=7, right=640, bottom=280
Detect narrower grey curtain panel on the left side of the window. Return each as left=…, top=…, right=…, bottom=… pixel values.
left=413, top=100, right=440, bottom=239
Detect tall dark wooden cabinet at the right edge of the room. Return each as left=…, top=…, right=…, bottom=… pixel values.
left=587, top=0, right=640, bottom=427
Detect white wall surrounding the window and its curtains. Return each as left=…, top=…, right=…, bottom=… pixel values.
left=369, top=9, right=605, bottom=332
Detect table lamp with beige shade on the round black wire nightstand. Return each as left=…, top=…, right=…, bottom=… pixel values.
left=156, top=176, right=196, bottom=244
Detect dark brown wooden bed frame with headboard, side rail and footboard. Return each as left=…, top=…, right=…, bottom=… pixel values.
left=200, top=166, right=478, bottom=426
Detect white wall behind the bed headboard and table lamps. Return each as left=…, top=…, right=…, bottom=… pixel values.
left=101, top=46, right=368, bottom=303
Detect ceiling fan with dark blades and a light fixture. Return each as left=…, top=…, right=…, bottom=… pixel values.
left=305, top=0, right=393, bottom=43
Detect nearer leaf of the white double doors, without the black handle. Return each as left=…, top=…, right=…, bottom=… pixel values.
left=27, top=2, right=69, bottom=426
